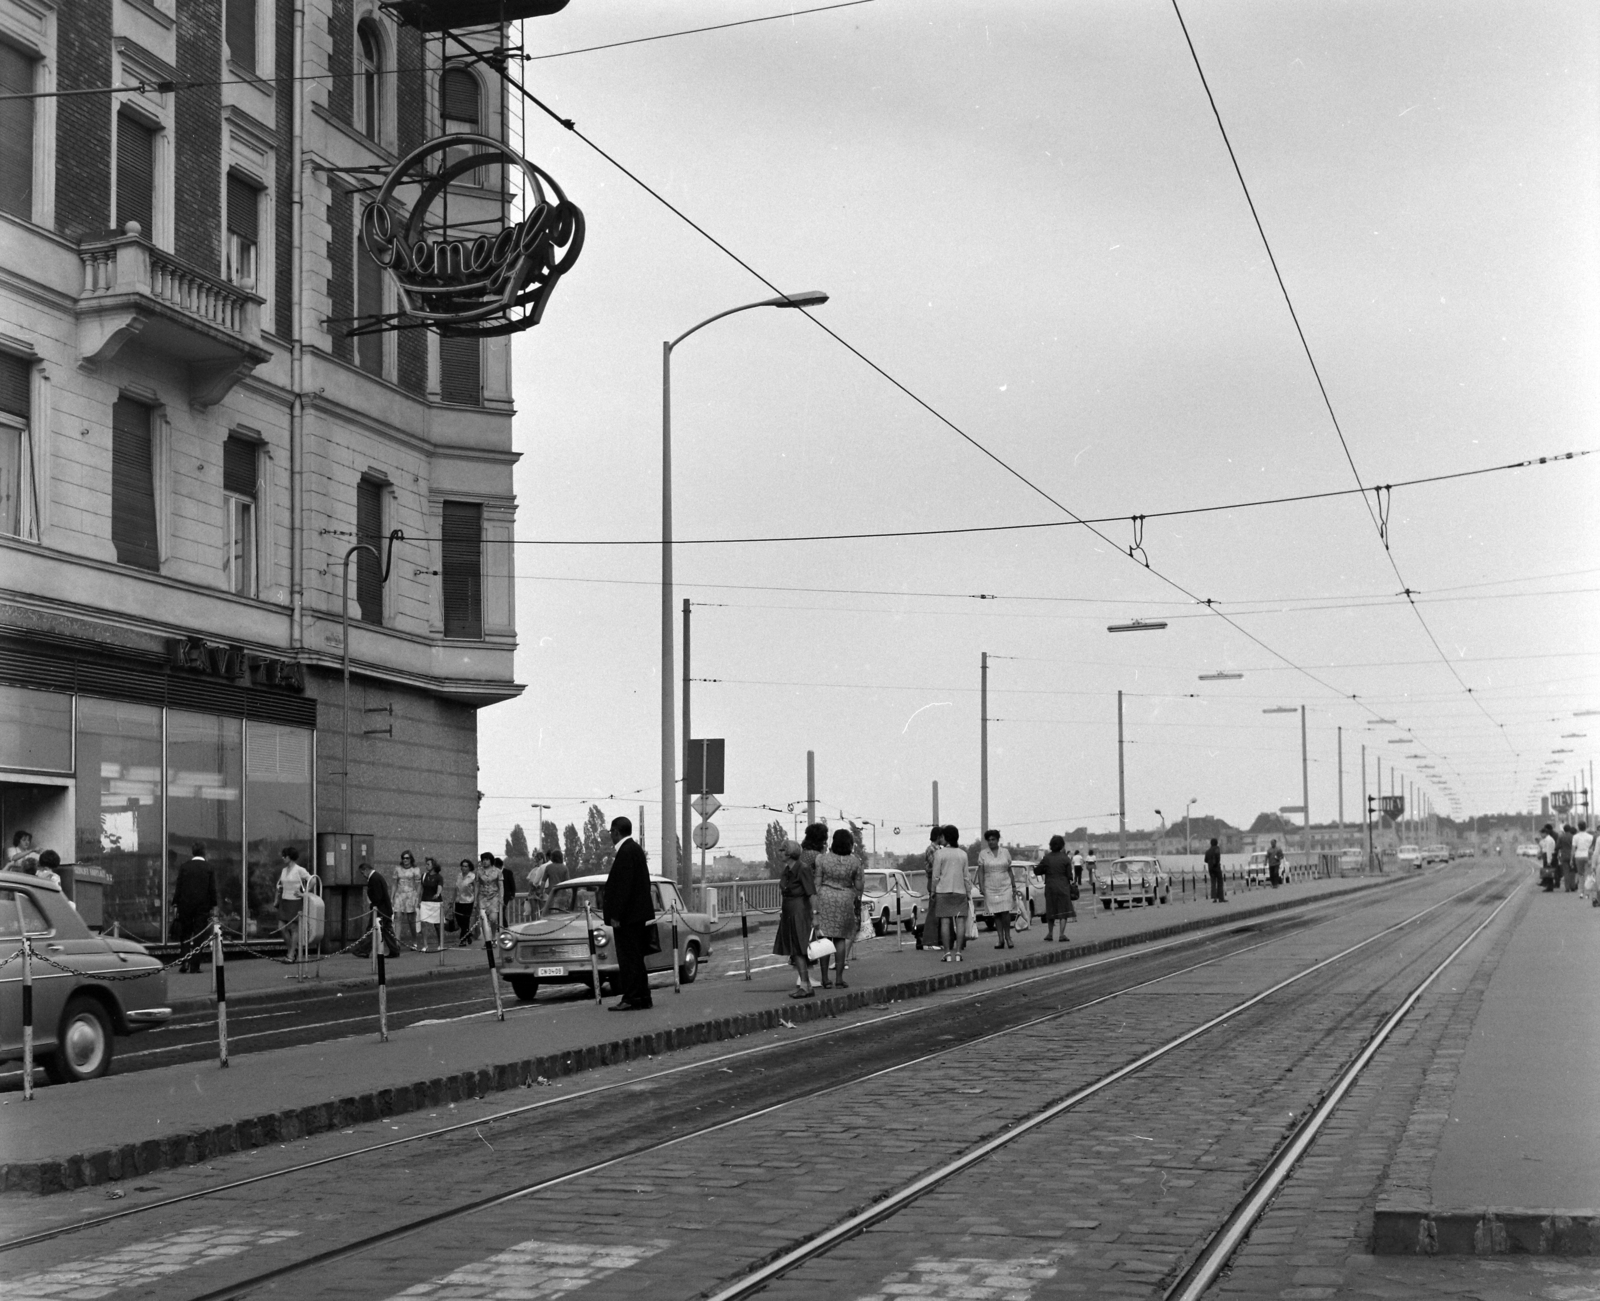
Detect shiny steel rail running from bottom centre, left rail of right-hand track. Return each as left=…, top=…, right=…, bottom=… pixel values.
left=699, top=882, right=1510, bottom=1301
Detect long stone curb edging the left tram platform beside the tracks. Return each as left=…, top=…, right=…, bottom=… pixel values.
left=0, top=875, right=1395, bottom=1194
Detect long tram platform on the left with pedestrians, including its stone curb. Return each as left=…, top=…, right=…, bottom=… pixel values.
left=0, top=877, right=1405, bottom=1192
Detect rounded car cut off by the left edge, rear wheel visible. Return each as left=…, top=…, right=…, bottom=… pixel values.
left=0, top=872, right=173, bottom=1083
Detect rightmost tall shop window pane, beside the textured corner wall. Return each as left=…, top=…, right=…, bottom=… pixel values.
left=245, top=720, right=315, bottom=936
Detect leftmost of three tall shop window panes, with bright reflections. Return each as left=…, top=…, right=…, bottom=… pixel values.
left=67, top=696, right=166, bottom=941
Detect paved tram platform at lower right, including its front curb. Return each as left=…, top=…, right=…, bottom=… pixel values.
left=1374, top=883, right=1600, bottom=1255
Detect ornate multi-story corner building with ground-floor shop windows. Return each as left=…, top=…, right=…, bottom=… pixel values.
left=0, top=0, right=520, bottom=939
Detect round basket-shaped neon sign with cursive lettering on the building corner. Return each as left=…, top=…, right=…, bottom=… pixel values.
left=352, top=134, right=584, bottom=334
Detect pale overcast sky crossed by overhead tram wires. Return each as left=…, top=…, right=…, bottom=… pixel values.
left=480, top=0, right=1600, bottom=859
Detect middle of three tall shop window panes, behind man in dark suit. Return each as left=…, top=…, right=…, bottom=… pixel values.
left=166, top=709, right=245, bottom=936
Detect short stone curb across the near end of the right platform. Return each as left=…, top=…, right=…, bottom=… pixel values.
left=1373, top=1207, right=1600, bottom=1256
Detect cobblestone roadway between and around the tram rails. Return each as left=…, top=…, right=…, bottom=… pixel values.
left=8, top=871, right=1510, bottom=1301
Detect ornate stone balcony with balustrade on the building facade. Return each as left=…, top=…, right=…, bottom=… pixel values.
left=77, top=222, right=272, bottom=406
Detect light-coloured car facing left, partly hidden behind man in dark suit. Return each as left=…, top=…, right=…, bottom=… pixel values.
left=498, top=875, right=712, bottom=1003
